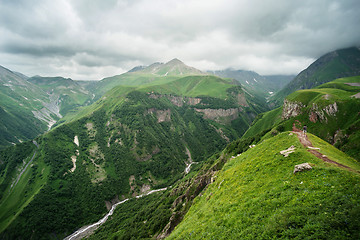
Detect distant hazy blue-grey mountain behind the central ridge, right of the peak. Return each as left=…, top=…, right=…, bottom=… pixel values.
left=208, top=69, right=294, bottom=96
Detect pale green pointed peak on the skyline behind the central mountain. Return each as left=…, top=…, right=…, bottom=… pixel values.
left=89, top=58, right=206, bottom=99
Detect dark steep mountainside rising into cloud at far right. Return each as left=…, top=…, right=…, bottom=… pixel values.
left=271, top=47, right=360, bottom=105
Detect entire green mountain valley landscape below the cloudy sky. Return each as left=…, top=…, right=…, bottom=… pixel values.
left=0, top=48, right=360, bottom=240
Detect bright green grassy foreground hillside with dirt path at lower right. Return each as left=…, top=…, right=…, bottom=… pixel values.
left=169, top=132, right=360, bottom=239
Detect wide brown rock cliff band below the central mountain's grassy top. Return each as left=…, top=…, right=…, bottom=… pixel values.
left=195, top=108, right=242, bottom=122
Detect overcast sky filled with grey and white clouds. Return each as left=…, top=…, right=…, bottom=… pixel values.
left=0, top=0, right=360, bottom=80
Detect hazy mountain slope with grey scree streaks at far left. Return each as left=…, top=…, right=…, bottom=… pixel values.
left=0, top=66, right=94, bottom=148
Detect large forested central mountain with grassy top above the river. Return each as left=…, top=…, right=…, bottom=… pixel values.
left=0, top=72, right=266, bottom=239
